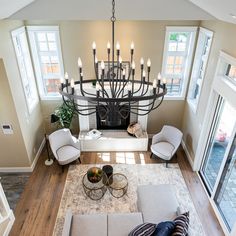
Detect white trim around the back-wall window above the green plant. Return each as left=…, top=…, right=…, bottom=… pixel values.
left=27, top=26, right=64, bottom=100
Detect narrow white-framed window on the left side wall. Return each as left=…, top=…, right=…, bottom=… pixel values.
left=12, top=27, right=38, bottom=114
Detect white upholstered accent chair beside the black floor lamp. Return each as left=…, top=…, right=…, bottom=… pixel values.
left=48, top=129, right=81, bottom=166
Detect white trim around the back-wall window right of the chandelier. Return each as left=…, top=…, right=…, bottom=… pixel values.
left=162, top=26, right=198, bottom=100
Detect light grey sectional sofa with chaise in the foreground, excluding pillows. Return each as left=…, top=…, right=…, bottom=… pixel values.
left=62, top=185, right=179, bottom=236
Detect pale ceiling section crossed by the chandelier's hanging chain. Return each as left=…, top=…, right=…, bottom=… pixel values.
left=7, top=0, right=214, bottom=20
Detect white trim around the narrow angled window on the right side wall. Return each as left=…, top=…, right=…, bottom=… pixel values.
left=187, top=27, right=214, bottom=113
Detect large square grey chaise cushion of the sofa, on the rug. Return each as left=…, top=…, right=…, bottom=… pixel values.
left=137, top=184, right=178, bottom=224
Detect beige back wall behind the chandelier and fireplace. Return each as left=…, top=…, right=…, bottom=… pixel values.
left=26, top=21, right=200, bottom=133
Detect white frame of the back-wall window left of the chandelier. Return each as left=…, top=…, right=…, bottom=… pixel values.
left=27, top=26, right=64, bottom=100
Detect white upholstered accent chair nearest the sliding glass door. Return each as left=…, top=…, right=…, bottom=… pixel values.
left=151, top=125, right=183, bottom=167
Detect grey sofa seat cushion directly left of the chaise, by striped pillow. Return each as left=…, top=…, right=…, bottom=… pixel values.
left=108, top=212, right=143, bottom=236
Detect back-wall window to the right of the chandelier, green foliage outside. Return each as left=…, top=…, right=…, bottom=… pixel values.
left=162, top=27, right=197, bottom=99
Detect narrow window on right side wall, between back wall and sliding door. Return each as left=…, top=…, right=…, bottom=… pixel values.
left=188, top=28, right=213, bottom=112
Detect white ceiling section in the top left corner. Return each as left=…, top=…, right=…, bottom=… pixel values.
left=0, top=0, right=35, bottom=19
